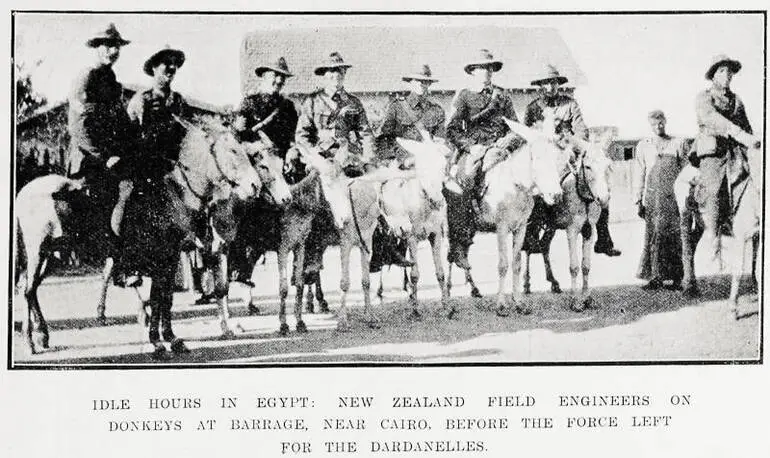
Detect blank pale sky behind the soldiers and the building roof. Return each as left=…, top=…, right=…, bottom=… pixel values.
left=16, top=14, right=765, bottom=137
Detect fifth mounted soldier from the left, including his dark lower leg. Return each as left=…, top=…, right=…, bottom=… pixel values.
left=369, top=65, right=446, bottom=272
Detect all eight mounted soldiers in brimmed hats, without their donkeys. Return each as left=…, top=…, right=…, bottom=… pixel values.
left=61, top=24, right=750, bottom=294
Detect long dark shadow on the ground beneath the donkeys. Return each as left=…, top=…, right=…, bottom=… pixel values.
left=16, top=275, right=759, bottom=366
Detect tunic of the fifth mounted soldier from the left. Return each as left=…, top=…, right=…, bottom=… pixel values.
left=375, top=93, right=446, bottom=160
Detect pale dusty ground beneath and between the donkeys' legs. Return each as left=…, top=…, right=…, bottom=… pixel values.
left=13, top=221, right=761, bottom=365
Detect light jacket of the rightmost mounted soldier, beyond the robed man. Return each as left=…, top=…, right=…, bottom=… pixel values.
left=695, top=87, right=753, bottom=157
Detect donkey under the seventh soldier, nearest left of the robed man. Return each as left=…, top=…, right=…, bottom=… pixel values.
left=524, top=133, right=612, bottom=312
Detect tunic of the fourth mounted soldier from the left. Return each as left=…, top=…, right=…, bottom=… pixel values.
left=297, top=89, right=371, bottom=156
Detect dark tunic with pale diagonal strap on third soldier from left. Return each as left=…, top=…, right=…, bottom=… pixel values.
left=238, top=93, right=299, bottom=158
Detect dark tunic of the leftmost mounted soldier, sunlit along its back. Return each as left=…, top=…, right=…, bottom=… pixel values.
left=68, top=65, right=133, bottom=179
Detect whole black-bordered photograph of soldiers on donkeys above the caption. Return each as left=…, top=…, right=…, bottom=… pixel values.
left=6, top=10, right=767, bottom=368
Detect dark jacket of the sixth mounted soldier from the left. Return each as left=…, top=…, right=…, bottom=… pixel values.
left=447, top=86, right=518, bottom=152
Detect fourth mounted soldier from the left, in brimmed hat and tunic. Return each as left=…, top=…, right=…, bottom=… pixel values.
left=297, top=52, right=372, bottom=175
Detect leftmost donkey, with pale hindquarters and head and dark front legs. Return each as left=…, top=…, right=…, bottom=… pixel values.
left=15, top=116, right=261, bottom=357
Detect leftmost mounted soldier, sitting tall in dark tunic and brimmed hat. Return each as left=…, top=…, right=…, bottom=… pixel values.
left=67, top=24, right=135, bottom=264
